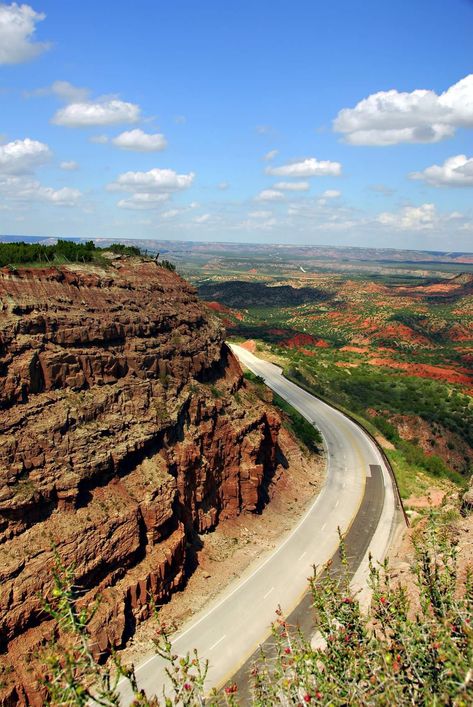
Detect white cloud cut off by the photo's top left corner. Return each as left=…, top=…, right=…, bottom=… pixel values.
left=0, top=3, right=50, bottom=64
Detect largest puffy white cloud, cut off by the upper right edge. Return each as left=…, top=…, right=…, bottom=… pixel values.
left=333, top=74, right=473, bottom=145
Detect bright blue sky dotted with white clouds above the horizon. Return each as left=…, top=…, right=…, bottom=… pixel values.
left=0, top=0, right=473, bottom=251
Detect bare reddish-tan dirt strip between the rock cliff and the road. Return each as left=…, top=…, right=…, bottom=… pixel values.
left=113, top=429, right=325, bottom=664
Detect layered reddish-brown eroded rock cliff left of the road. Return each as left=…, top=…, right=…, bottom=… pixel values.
left=0, top=259, right=279, bottom=704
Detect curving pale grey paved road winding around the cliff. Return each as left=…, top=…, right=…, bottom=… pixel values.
left=121, top=346, right=397, bottom=705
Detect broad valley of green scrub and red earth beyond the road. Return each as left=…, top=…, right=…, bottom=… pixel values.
left=189, top=257, right=473, bottom=498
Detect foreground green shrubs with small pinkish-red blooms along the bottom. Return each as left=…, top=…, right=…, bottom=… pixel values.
left=42, top=509, right=473, bottom=707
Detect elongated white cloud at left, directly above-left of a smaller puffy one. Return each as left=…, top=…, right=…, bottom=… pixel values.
left=52, top=98, right=140, bottom=128
